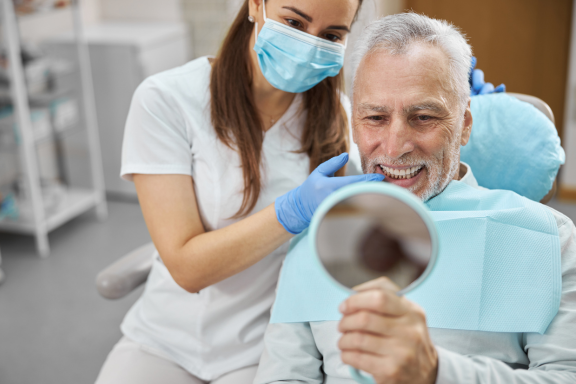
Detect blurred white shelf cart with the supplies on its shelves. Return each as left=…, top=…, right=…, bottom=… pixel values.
left=0, top=0, right=107, bottom=256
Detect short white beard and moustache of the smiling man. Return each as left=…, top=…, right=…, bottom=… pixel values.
left=360, top=135, right=460, bottom=201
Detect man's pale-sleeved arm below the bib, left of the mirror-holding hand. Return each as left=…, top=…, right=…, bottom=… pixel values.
left=254, top=323, right=324, bottom=384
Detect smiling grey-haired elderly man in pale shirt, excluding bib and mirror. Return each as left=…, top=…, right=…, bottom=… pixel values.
left=255, top=13, right=576, bottom=384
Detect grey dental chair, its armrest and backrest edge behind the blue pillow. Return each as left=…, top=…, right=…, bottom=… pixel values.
left=95, top=92, right=556, bottom=300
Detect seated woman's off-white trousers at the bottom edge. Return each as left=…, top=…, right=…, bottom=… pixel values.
left=96, top=337, right=258, bottom=384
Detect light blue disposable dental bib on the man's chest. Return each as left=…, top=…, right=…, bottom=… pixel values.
left=270, top=181, right=562, bottom=334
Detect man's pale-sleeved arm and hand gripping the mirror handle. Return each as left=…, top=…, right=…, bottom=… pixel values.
left=340, top=217, right=576, bottom=384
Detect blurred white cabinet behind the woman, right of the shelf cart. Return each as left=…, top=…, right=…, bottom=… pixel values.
left=42, top=21, right=189, bottom=199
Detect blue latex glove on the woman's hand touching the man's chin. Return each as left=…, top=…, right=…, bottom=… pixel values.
left=274, top=153, right=384, bottom=235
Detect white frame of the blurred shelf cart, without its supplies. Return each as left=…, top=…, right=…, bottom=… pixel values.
left=0, top=0, right=107, bottom=257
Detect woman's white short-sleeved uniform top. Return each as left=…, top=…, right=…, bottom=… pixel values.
left=121, top=57, right=358, bottom=380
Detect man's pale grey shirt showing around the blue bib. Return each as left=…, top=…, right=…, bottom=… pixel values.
left=254, top=163, right=576, bottom=384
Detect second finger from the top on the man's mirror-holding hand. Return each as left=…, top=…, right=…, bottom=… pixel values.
left=338, top=311, right=405, bottom=337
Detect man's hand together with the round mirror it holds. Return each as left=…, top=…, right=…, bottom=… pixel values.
left=312, top=183, right=438, bottom=384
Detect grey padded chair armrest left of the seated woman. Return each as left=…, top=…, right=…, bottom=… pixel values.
left=96, top=243, right=155, bottom=300
